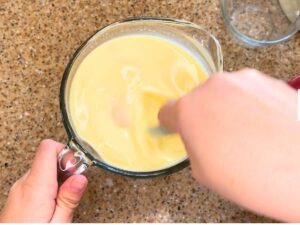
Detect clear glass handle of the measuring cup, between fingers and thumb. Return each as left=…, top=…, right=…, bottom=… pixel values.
left=57, top=142, right=92, bottom=182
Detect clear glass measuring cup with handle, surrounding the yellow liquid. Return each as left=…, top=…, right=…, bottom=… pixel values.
left=58, top=18, right=223, bottom=179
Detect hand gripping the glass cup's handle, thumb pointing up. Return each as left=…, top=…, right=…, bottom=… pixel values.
left=0, top=140, right=87, bottom=223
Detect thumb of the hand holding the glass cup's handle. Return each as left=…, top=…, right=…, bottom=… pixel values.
left=51, top=175, right=88, bottom=223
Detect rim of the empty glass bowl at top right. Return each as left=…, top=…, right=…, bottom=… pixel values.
left=220, top=0, right=300, bottom=47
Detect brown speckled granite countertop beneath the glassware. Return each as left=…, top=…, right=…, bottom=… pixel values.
left=0, top=0, right=300, bottom=222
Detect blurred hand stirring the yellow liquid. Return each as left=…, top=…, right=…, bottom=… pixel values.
left=159, top=69, right=300, bottom=221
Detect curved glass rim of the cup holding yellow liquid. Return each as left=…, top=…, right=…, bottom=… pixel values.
left=59, top=17, right=223, bottom=178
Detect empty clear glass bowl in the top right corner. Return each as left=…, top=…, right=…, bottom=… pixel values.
left=220, top=0, right=300, bottom=47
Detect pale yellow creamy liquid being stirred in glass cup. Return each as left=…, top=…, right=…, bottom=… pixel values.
left=69, top=35, right=207, bottom=171
